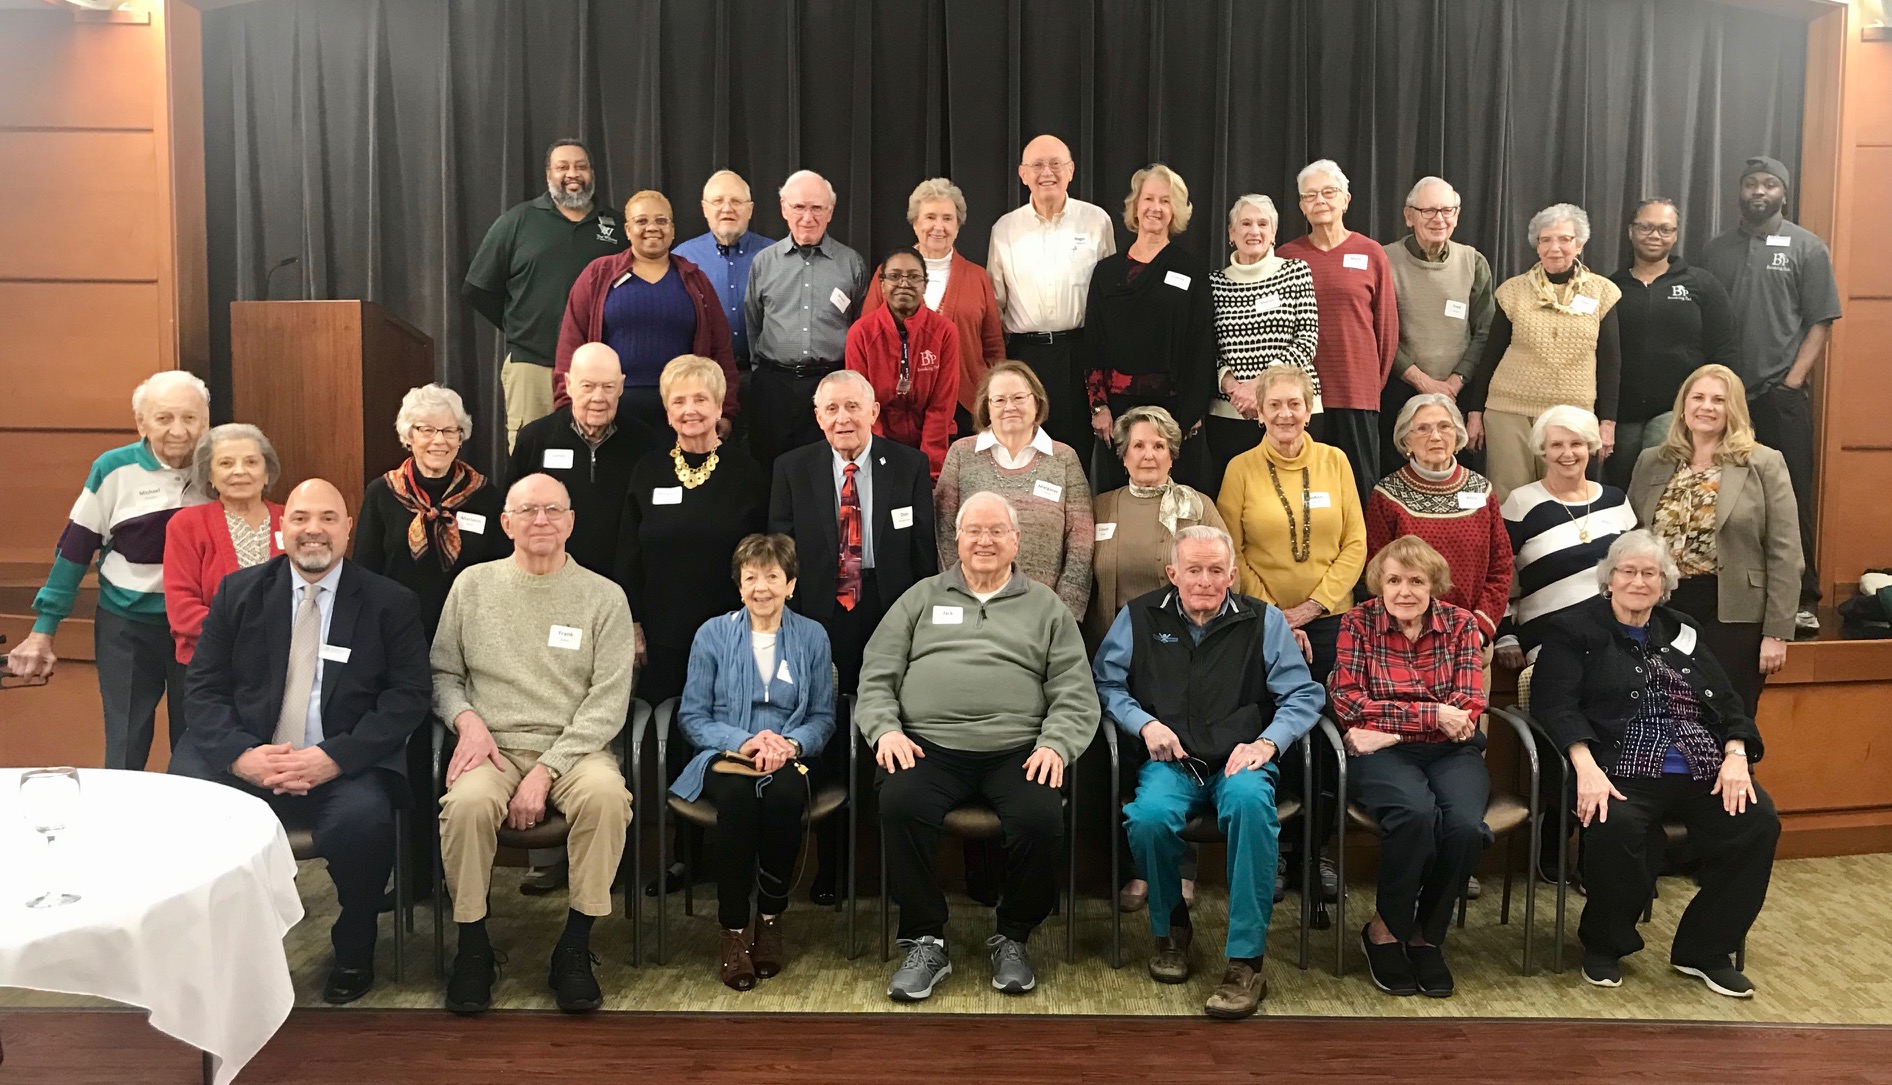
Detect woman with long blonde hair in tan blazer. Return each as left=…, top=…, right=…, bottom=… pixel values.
left=1629, top=365, right=1803, bottom=716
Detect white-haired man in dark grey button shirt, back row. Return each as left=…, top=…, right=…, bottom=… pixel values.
left=744, top=170, right=867, bottom=471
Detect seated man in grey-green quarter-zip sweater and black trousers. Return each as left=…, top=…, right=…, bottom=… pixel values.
left=853, top=490, right=1099, bottom=1002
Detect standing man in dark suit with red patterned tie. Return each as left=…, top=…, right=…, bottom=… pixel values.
left=768, top=369, right=938, bottom=903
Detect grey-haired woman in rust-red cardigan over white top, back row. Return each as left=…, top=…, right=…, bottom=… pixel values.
left=861, top=178, right=1005, bottom=433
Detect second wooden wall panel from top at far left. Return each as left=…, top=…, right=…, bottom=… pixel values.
left=0, top=131, right=168, bottom=282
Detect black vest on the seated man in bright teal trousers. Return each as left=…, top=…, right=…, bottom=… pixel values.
left=1128, top=587, right=1275, bottom=769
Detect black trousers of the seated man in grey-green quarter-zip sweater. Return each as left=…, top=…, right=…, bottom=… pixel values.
left=874, top=738, right=1063, bottom=941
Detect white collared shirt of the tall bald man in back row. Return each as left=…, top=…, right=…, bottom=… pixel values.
left=986, top=197, right=1116, bottom=331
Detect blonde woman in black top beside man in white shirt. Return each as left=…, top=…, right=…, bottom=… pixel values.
left=1082, top=163, right=1215, bottom=492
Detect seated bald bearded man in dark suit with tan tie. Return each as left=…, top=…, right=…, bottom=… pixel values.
left=170, top=479, right=433, bottom=1004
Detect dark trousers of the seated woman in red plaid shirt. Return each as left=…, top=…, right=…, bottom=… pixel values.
left=1347, top=733, right=1491, bottom=945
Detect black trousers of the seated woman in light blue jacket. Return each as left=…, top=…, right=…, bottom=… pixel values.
left=704, top=769, right=812, bottom=930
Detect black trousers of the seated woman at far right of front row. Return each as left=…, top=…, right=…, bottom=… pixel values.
left=1576, top=774, right=1780, bottom=966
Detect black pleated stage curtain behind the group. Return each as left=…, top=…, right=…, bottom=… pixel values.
left=204, top=0, right=1807, bottom=468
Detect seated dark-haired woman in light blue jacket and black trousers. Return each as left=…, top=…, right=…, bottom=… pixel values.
left=670, top=534, right=834, bottom=990
